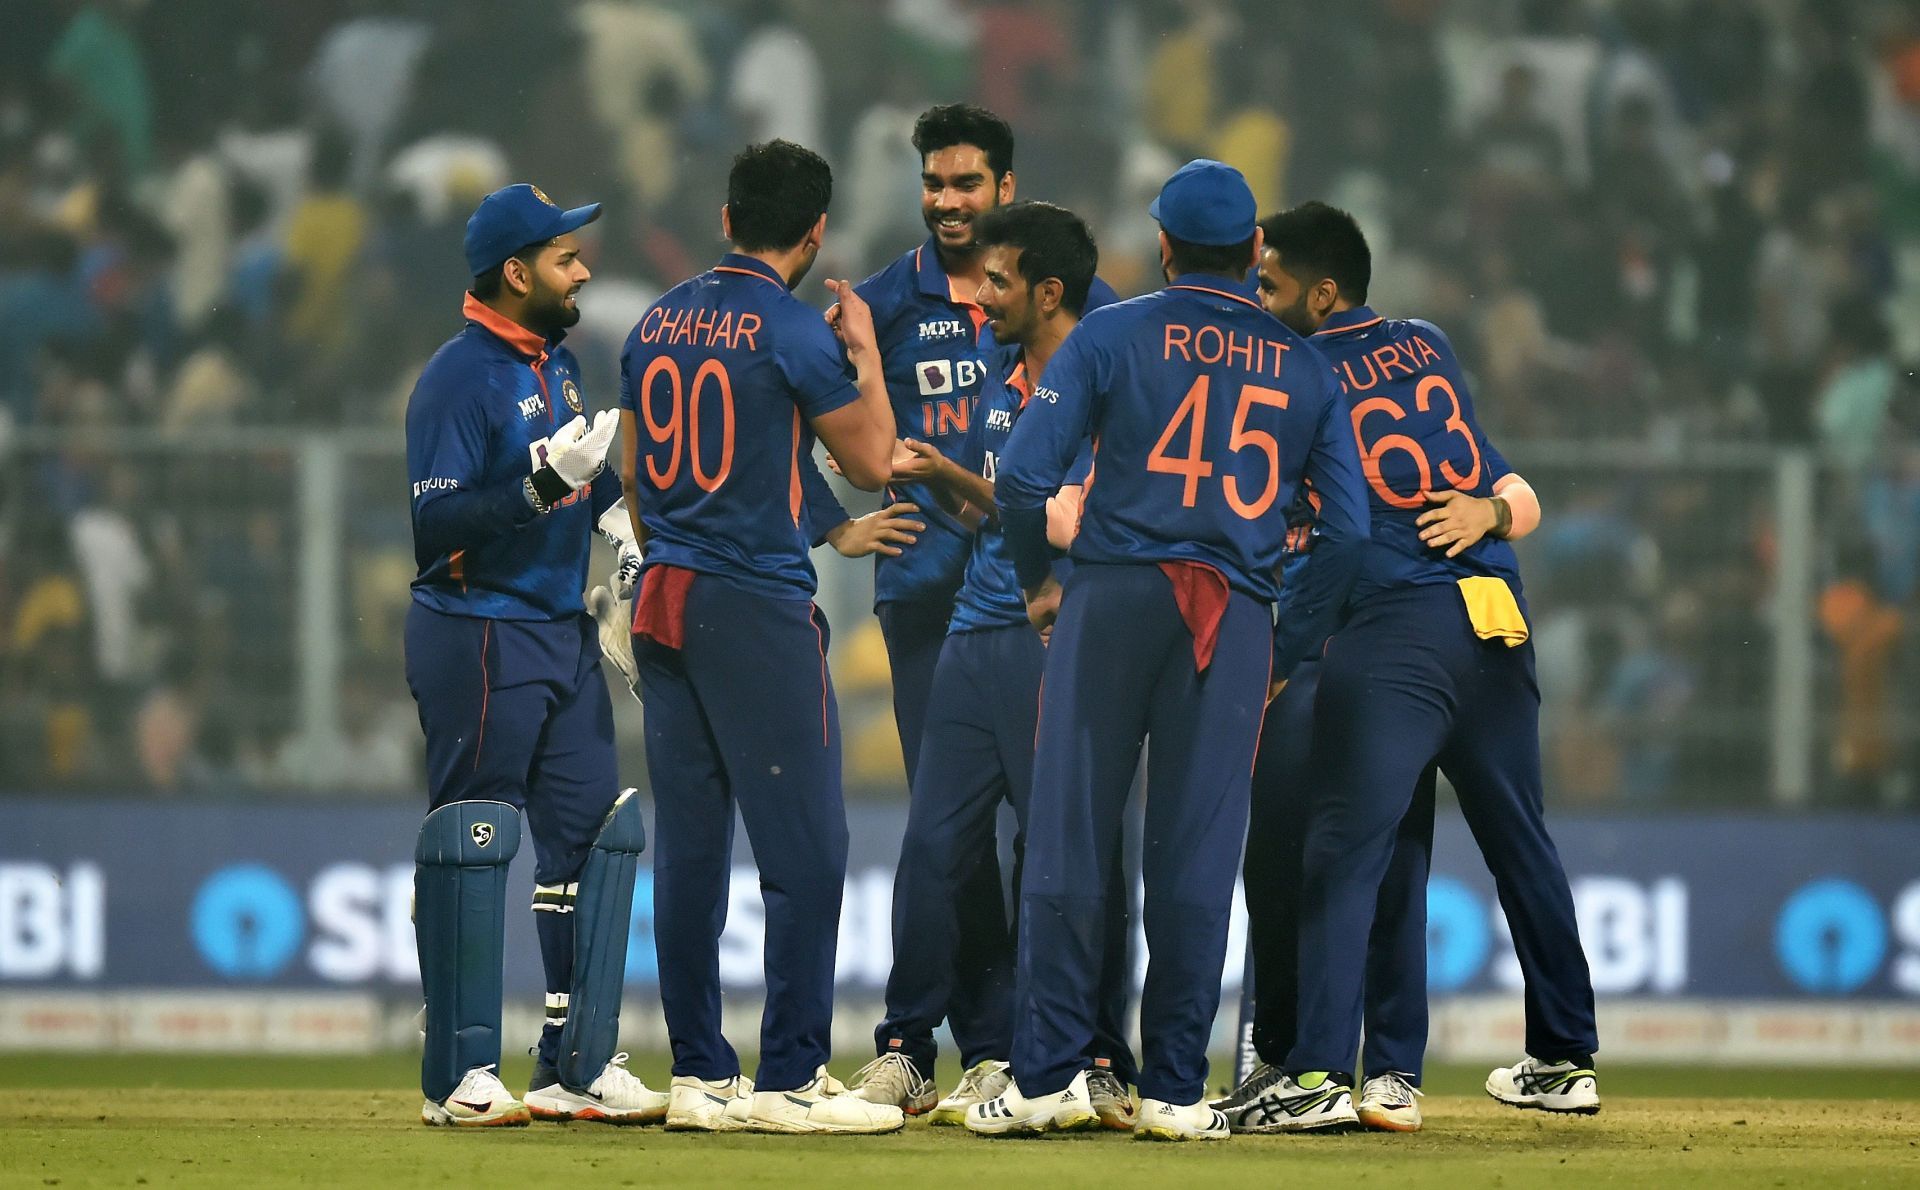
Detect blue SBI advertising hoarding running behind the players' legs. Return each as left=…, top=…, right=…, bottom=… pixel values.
left=0, top=798, right=1920, bottom=1000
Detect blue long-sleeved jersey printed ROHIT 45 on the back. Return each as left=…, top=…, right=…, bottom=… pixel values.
left=995, top=274, right=1367, bottom=678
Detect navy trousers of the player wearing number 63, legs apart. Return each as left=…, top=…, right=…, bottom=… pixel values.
left=1286, top=583, right=1599, bottom=1073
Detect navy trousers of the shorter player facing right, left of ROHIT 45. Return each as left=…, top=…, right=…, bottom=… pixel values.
left=874, top=624, right=1135, bottom=1083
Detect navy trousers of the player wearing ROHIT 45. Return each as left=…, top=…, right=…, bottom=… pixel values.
left=1014, top=564, right=1273, bottom=1104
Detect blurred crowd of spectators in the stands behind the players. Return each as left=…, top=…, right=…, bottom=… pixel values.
left=0, top=0, right=1920, bottom=800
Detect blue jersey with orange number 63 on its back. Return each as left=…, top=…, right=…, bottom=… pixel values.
left=1313, top=305, right=1521, bottom=601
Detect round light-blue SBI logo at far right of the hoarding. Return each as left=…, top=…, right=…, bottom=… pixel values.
left=1774, top=877, right=1920, bottom=996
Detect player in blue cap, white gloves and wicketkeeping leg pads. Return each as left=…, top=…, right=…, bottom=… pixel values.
left=405, top=184, right=666, bottom=1125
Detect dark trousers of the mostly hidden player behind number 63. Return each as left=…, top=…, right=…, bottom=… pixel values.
left=1242, top=658, right=1434, bottom=1086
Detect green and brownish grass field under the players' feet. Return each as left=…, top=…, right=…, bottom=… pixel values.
left=0, top=1054, right=1920, bottom=1190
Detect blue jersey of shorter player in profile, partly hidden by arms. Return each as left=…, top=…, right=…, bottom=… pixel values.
left=947, top=345, right=1092, bottom=633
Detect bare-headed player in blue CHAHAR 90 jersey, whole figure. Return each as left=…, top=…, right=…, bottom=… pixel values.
left=620, top=140, right=904, bottom=1132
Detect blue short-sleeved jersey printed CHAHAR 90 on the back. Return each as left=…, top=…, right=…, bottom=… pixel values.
left=620, top=253, right=860, bottom=599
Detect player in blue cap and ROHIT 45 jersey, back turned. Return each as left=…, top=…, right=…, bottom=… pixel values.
left=966, top=161, right=1367, bottom=1140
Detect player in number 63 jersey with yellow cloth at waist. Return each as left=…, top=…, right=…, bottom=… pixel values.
left=1236, top=203, right=1599, bottom=1127
